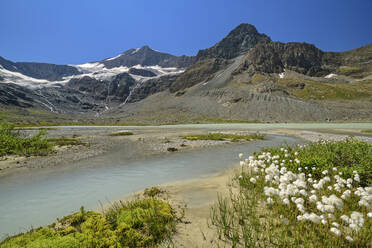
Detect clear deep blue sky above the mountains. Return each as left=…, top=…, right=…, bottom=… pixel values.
left=0, top=0, right=372, bottom=64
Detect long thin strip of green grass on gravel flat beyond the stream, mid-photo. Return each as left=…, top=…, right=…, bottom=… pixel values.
left=181, top=133, right=264, bottom=142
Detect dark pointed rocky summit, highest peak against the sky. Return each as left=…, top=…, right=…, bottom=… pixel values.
left=197, top=23, right=271, bottom=60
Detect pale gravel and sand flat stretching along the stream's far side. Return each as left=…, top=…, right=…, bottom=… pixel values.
left=0, top=124, right=372, bottom=178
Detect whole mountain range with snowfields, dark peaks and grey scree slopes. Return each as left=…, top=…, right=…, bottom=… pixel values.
left=0, top=24, right=372, bottom=123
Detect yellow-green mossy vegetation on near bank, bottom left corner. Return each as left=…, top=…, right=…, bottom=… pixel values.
left=0, top=197, right=177, bottom=248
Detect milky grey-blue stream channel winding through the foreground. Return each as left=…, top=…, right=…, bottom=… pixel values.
left=0, top=135, right=302, bottom=240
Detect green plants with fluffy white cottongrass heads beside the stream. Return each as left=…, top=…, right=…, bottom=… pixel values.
left=211, top=139, right=372, bottom=247
